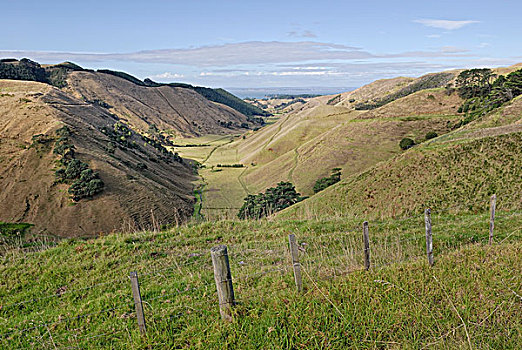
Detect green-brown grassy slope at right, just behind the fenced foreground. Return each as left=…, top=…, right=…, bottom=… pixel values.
left=281, top=98, right=522, bottom=217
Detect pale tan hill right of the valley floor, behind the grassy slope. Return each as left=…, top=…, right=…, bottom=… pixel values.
left=176, top=69, right=462, bottom=217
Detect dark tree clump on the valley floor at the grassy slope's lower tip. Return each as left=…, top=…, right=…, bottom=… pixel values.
left=238, top=182, right=304, bottom=219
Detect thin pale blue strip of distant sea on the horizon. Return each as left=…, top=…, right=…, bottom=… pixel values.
left=225, top=87, right=356, bottom=98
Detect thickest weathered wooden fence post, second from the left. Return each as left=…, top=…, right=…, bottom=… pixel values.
left=210, top=245, right=236, bottom=321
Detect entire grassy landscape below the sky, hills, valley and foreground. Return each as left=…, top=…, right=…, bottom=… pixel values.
left=0, top=59, right=522, bottom=349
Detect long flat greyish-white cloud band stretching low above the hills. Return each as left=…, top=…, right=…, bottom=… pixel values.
left=0, top=41, right=472, bottom=68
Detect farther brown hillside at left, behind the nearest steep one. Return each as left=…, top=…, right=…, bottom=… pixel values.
left=66, top=72, right=255, bottom=137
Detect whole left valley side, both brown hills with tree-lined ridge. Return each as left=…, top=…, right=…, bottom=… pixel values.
left=0, top=59, right=261, bottom=239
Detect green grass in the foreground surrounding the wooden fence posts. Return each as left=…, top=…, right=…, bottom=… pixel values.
left=0, top=211, right=522, bottom=349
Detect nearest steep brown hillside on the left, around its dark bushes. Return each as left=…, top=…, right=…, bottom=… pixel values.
left=0, top=80, right=193, bottom=236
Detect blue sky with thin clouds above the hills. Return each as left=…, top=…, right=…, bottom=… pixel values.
left=0, top=0, right=522, bottom=88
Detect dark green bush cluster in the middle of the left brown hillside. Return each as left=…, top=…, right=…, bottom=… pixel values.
left=53, top=126, right=105, bottom=202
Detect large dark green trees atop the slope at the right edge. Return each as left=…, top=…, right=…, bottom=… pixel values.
left=456, top=68, right=522, bottom=127
